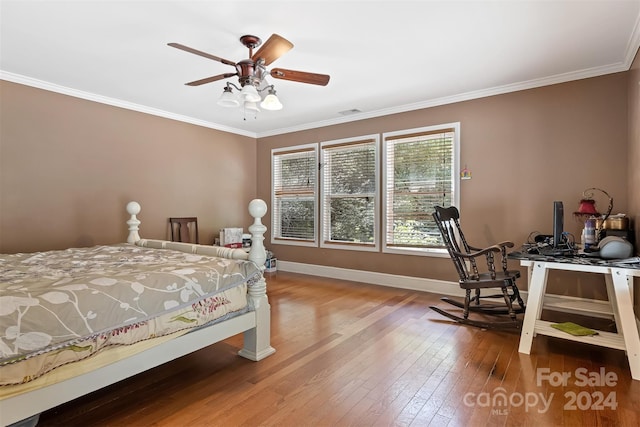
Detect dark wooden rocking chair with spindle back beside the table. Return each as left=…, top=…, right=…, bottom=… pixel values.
left=431, top=206, right=525, bottom=329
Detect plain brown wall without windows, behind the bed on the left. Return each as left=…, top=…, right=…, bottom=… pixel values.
left=0, top=81, right=256, bottom=253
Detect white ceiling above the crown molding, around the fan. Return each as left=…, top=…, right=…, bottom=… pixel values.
left=0, top=0, right=640, bottom=137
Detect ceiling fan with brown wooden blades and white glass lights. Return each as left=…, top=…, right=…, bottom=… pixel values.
left=168, top=34, right=329, bottom=109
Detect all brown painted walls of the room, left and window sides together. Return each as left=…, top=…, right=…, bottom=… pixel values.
left=0, top=65, right=640, bottom=298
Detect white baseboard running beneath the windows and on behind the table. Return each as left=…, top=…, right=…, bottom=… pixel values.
left=278, top=260, right=612, bottom=318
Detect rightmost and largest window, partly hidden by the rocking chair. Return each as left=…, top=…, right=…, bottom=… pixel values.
left=383, top=123, right=460, bottom=253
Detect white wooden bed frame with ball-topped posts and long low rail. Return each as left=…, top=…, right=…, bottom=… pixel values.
left=0, top=199, right=275, bottom=426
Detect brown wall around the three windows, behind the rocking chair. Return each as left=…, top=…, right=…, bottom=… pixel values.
left=258, top=73, right=628, bottom=288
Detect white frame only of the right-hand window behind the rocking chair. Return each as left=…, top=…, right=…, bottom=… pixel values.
left=381, top=122, right=460, bottom=257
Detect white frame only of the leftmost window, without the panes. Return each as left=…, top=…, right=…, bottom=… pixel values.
left=271, top=143, right=319, bottom=247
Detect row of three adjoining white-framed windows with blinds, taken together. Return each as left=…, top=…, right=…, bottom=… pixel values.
left=271, top=123, right=460, bottom=256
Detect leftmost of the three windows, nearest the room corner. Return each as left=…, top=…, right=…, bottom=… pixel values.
left=271, top=144, right=318, bottom=246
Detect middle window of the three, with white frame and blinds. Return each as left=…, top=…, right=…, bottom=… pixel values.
left=320, top=135, right=379, bottom=250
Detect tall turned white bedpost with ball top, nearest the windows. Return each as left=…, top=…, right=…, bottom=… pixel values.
left=238, top=199, right=276, bottom=361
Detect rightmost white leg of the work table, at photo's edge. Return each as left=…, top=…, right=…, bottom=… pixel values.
left=611, top=268, right=640, bottom=380
